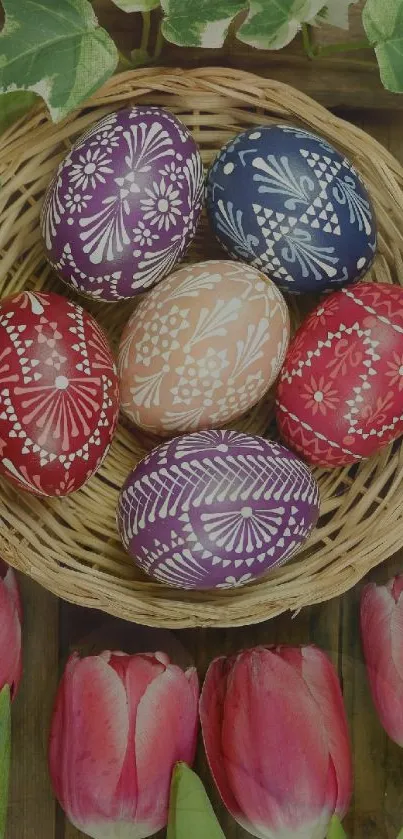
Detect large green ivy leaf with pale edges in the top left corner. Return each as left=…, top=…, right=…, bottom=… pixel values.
left=0, top=0, right=118, bottom=120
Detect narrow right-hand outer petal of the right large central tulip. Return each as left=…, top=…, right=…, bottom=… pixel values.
left=302, top=646, right=353, bottom=818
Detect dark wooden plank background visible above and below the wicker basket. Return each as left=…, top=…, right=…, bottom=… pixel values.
left=7, top=0, right=403, bottom=839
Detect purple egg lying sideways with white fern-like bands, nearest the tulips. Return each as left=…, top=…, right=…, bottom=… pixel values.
left=117, top=431, right=319, bottom=589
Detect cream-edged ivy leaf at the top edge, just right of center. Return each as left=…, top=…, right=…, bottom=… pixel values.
left=238, top=0, right=324, bottom=50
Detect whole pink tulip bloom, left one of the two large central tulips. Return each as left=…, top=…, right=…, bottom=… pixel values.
left=49, top=652, right=199, bottom=839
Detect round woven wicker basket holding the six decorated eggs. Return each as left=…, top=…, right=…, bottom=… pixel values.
left=0, top=68, right=403, bottom=627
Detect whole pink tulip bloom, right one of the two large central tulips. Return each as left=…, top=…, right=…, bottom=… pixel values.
left=200, top=647, right=352, bottom=839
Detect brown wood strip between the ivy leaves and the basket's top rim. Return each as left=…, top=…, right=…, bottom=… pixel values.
left=94, top=0, right=403, bottom=110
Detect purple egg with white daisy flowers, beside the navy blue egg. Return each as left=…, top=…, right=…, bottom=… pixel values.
left=41, top=106, right=203, bottom=301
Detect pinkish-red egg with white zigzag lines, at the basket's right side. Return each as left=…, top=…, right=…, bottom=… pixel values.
left=277, top=283, right=403, bottom=466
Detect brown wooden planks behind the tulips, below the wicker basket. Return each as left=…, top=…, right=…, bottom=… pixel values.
left=6, top=551, right=403, bottom=839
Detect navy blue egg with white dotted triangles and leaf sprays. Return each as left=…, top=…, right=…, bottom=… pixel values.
left=207, top=125, right=376, bottom=293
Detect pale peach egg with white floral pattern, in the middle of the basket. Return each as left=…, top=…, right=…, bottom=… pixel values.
left=118, top=260, right=289, bottom=436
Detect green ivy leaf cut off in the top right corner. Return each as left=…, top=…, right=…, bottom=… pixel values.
left=362, top=0, right=403, bottom=93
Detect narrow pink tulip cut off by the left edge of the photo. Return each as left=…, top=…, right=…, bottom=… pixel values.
left=0, top=560, right=22, bottom=699
